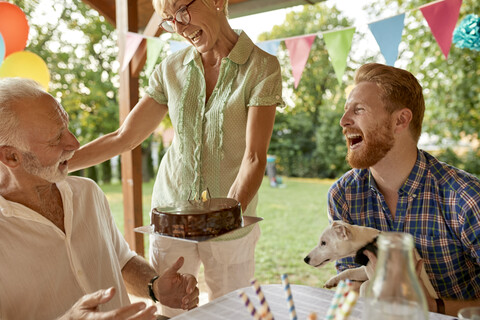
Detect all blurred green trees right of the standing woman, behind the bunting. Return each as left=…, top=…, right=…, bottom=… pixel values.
left=260, top=0, right=480, bottom=178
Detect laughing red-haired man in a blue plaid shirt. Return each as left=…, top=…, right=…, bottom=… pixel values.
left=328, top=63, right=480, bottom=315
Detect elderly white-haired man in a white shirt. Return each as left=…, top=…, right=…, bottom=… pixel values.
left=0, top=78, right=198, bottom=319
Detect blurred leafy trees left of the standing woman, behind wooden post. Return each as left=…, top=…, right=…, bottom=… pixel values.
left=14, top=0, right=171, bottom=183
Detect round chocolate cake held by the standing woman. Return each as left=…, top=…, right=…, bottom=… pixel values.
left=151, top=198, right=242, bottom=238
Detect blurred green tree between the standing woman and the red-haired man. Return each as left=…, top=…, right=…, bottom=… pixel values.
left=259, top=3, right=353, bottom=178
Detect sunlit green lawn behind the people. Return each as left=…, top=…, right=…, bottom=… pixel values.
left=101, top=178, right=335, bottom=287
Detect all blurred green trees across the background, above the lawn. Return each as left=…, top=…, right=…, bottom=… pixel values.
left=13, top=0, right=480, bottom=183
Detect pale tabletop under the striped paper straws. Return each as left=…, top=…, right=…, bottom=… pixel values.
left=172, top=284, right=454, bottom=320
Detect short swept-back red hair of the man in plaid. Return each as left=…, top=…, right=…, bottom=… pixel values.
left=355, top=63, right=425, bottom=141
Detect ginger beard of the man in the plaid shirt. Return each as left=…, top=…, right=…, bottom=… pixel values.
left=347, top=121, right=394, bottom=169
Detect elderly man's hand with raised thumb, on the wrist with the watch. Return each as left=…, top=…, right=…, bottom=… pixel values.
left=154, top=257, right=199, bottom=310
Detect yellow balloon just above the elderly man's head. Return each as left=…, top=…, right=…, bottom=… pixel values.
left=0, top=51, right=50, bottom=91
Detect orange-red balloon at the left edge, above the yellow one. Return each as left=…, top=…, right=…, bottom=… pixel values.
left=0, top=1, right=29, bottom=57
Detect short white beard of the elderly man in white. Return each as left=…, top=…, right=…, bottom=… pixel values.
left=22, top=151, right=74, bottom=183
